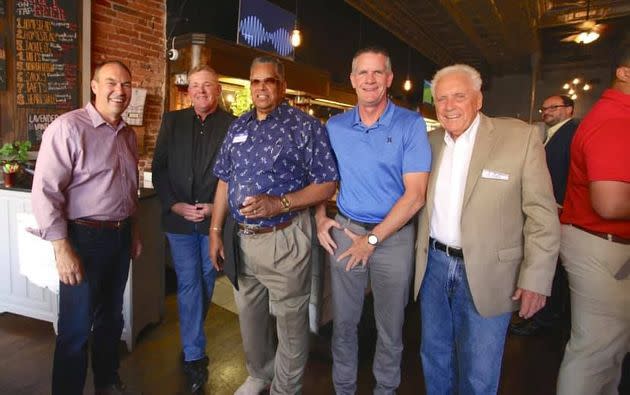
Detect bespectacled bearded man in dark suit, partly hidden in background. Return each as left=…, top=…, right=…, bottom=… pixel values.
left=510, top=95, right=579, bottom=336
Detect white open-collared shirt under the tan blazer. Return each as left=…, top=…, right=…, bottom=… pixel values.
left=430, top=114, right=480, bottom=247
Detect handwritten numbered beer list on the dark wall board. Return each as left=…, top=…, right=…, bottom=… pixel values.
left=15, top=0, right=79, bottom=110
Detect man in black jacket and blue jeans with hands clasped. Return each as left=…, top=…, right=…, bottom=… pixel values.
left=152, top=65, right=234, bottom=392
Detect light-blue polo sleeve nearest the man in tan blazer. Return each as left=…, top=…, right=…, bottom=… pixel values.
left=403, top=117, right=431, bottom=174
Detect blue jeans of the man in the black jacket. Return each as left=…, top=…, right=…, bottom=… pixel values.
left=166, top=232, right=217, bottom=361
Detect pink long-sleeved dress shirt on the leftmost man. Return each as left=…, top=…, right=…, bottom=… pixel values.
left=30, top=103, right=138, bottom=240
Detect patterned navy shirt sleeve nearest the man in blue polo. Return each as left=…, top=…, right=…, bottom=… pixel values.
left=304, top=120, right=339, bottom=184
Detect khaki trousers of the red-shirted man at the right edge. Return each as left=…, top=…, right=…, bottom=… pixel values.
left=557, top=225, right=630, bottom=395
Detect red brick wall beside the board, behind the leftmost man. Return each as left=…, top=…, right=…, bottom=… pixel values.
left=92, top=0, right=166, bottom=168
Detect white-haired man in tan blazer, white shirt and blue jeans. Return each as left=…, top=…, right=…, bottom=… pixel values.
left=415, top=65, right=560, bottom=395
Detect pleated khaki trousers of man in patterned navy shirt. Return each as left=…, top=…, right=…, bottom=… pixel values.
left=234, top=211, right=312, bottom=394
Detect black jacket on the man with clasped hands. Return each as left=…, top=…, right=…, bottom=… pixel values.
left=152, top=107, right=234, bottom=234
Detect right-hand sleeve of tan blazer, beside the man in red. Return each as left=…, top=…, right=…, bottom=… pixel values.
left=518, top=127, right=560, bottom=295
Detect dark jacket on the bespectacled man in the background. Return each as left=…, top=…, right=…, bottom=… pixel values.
left=545, top=119, right=580, bottom=205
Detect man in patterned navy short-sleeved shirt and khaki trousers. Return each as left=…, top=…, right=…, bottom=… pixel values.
left=210, top=56, right=338, bottom=395
